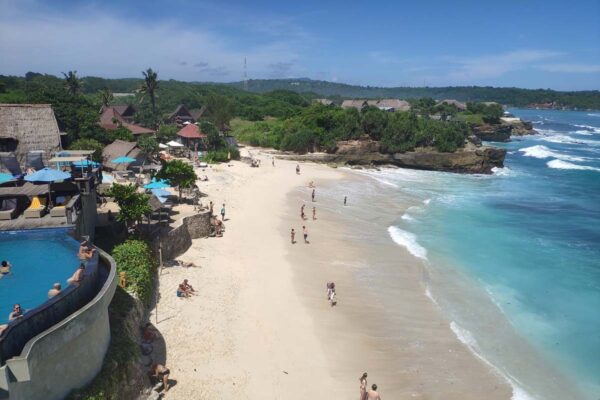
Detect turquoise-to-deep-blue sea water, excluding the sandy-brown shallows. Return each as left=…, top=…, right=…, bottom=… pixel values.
left=371, top=110, right=600, bottom=399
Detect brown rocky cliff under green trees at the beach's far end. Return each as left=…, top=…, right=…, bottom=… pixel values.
left=279, top=140, right=506, bottom=174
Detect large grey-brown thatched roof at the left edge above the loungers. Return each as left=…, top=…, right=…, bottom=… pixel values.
left=0, top=104, right=61, bottom=164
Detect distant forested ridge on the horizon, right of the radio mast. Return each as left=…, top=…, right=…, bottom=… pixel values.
left=229, top=78, right=600, bottom=110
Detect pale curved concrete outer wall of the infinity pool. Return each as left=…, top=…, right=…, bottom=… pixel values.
left=0, top=249, right=117, bottom=400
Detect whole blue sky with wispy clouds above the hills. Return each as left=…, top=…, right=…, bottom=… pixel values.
left=0, top=0, right=600, bottom=90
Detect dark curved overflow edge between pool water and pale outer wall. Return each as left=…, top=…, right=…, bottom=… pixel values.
left=0, top=251, right=109, bottom=366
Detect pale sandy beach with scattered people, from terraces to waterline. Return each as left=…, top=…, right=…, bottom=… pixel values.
left=151, top=149, right=511, bottom=399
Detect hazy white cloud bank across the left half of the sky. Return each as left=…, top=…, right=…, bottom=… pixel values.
left=0, top=0, right=302, bottom=81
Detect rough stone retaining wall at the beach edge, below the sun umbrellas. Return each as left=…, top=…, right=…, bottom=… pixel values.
left=152, top=211, right=210, bottom=260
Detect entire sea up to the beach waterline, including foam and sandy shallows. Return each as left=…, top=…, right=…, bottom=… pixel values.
left=329, top=109, right=600, bottom=400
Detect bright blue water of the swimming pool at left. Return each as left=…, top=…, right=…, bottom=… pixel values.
left=0, top=229, right=79, bottom=324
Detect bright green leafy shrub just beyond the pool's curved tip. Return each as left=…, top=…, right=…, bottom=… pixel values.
left=112, top=239, right=156, bottom=304
